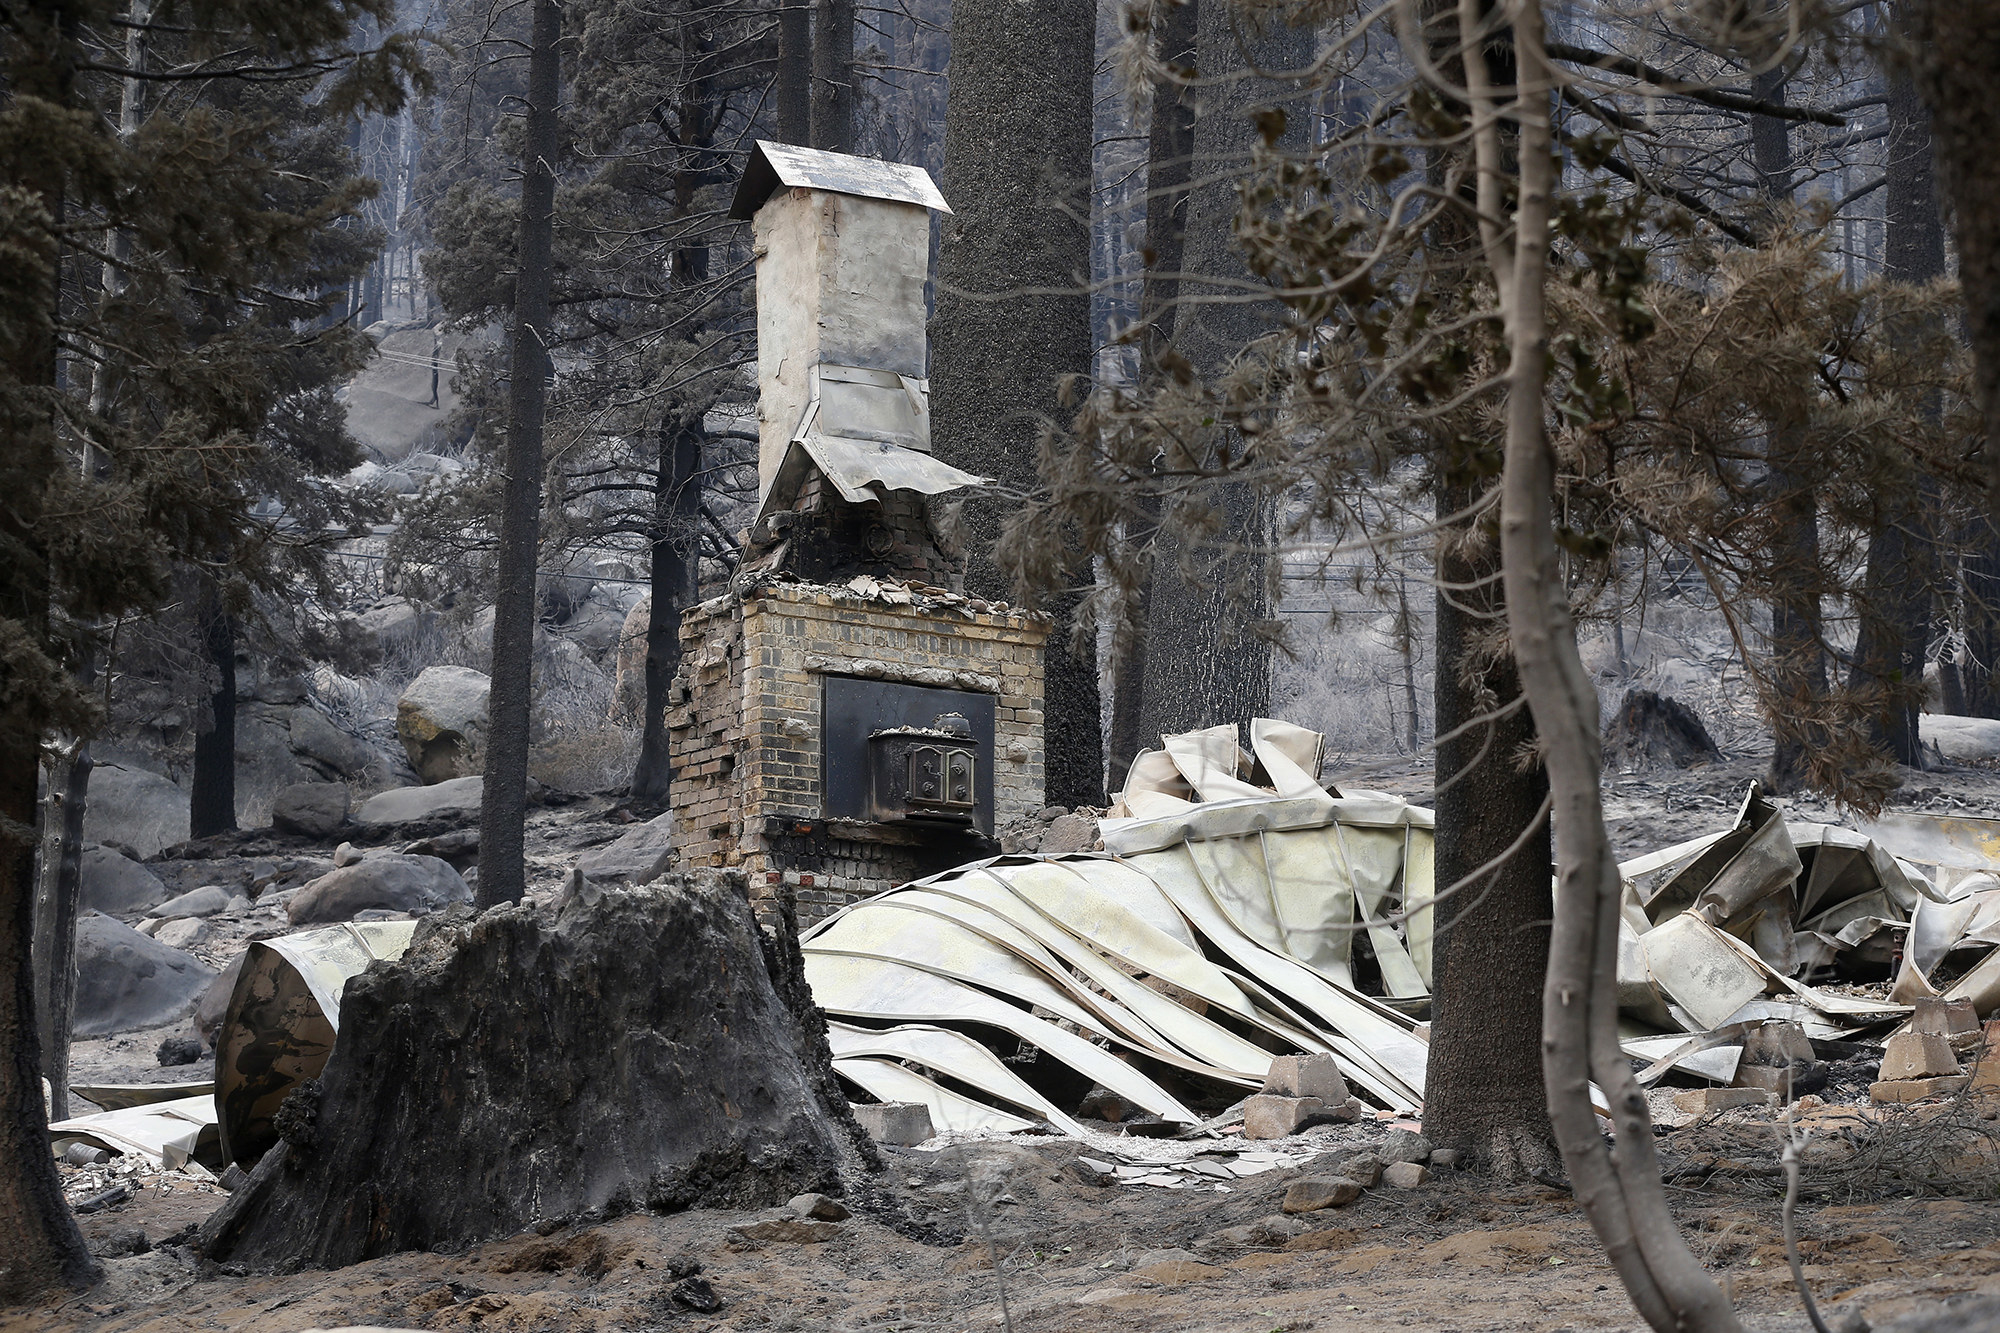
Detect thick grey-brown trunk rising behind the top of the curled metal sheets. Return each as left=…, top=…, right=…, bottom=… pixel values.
left=1140, top=4, right=1312, bottom=739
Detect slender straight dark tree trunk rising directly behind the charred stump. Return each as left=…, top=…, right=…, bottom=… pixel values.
left=478, top=0, right=562, bottom=909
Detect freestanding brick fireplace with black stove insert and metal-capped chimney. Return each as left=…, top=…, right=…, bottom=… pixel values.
left=666, top=144, right=1048, bottom=925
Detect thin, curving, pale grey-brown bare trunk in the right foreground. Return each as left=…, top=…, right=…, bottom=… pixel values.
left=1460, top=0, right=1742, bottom=1333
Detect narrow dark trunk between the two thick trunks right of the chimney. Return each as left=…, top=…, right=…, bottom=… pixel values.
left=1108, top=0, right=1200, bottom=791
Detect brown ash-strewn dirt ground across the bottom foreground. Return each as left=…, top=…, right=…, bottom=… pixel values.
left=11, top=1113, right=2000, bottom=1333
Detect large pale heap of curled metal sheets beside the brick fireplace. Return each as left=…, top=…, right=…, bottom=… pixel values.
left=802, top=719, right=1434, bottom=1129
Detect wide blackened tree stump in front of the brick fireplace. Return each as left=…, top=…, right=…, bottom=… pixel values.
left=200, top=875, right=880, bottom=1267
